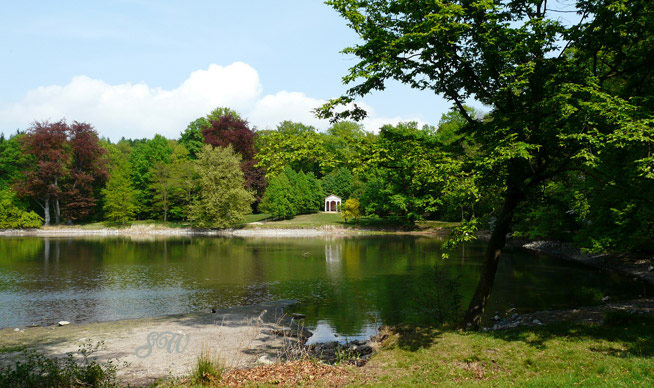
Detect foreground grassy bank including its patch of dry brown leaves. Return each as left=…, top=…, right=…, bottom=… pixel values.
left=5, top=313, right=654, bottom=388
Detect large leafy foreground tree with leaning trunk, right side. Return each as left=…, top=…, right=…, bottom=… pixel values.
left=319, top=0, right=654, bottom=328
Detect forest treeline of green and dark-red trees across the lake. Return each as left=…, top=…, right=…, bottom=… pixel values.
left=0, top=101, right=654, bottom=255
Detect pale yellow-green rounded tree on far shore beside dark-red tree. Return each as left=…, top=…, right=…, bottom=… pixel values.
left=189, top=145, right=254, bottom=228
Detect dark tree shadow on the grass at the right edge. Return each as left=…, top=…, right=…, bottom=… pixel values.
left=485, top=314, right=654, bottom=357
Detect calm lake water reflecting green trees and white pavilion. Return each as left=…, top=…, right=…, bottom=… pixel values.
left=0, top=236, right=651, bottom=339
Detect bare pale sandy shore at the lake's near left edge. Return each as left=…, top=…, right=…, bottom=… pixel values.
left=0, top=300, right=310, bottom=386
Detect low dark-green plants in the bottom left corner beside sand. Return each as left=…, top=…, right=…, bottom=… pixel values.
left=0, top=342, right=116, bottom=388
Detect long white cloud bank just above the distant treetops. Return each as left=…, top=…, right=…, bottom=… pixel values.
left=0, top=62, right=426, bottom=140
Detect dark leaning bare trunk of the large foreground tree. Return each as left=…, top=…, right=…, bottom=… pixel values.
left=463, top=186, right=523, bottom=330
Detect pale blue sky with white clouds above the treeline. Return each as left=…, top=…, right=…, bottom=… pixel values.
left=0, top=0, right=462, bottom=139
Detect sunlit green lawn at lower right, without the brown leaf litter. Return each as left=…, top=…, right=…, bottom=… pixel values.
left=362, top=318, right=654, bottom=387
